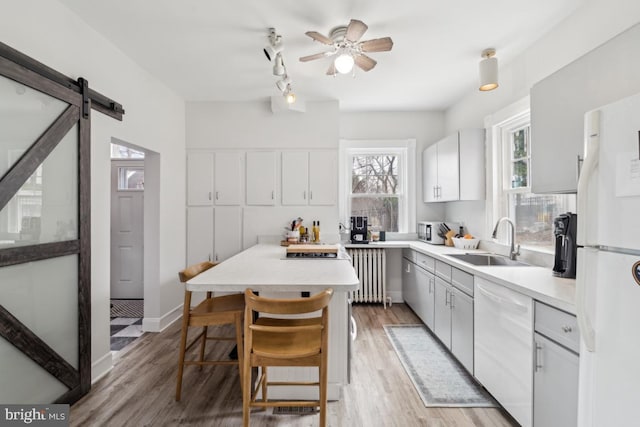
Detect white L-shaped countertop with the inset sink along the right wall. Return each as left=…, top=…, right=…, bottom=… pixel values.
left=345, top=240, right=576, bottom=314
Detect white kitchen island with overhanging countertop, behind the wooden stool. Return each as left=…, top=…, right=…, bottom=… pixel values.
left=186, top=244, right=359, bottom=400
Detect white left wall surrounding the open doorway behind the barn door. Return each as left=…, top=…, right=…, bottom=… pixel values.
left=0, top=0, right=185, bottom=379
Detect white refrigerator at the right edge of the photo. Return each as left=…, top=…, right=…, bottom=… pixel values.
left=576, top=94, right=640, bottom=427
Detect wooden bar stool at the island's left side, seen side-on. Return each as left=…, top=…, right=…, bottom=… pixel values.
left=176, top=261, right=244, bottom=401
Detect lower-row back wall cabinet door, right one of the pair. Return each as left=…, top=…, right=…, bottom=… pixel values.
left=213, top=206, right=242, bottom=262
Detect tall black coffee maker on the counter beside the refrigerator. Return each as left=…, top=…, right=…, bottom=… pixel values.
left=553, top=212, right=578, bottom=279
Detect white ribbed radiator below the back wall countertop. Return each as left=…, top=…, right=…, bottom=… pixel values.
left=347, top=248, right=391, bottom=308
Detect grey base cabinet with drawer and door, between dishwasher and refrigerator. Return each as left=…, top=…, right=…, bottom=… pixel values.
left=533, top=302, right=580, bottom=427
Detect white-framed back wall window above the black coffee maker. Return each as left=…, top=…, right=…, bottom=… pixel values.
left=340, top=140, right=415, bottom=233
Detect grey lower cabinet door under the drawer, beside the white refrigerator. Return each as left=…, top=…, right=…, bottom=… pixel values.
left=533, top=333, right=580, bottom=427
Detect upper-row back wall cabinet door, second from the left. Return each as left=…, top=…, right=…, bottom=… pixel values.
left=214, top=152, right=242, bottom=205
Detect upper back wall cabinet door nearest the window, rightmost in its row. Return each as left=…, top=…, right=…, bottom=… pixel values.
left=309, top=151, right=338, bottom=206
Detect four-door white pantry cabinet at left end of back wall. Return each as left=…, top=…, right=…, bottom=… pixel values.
left=187, top=152, right=243, bottom=265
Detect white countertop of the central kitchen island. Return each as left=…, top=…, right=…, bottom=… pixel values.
left=187, top=244, right=359, bottom=292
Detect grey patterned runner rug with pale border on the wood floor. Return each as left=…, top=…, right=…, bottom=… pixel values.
left=384, top=325, right=498, bottom=407
